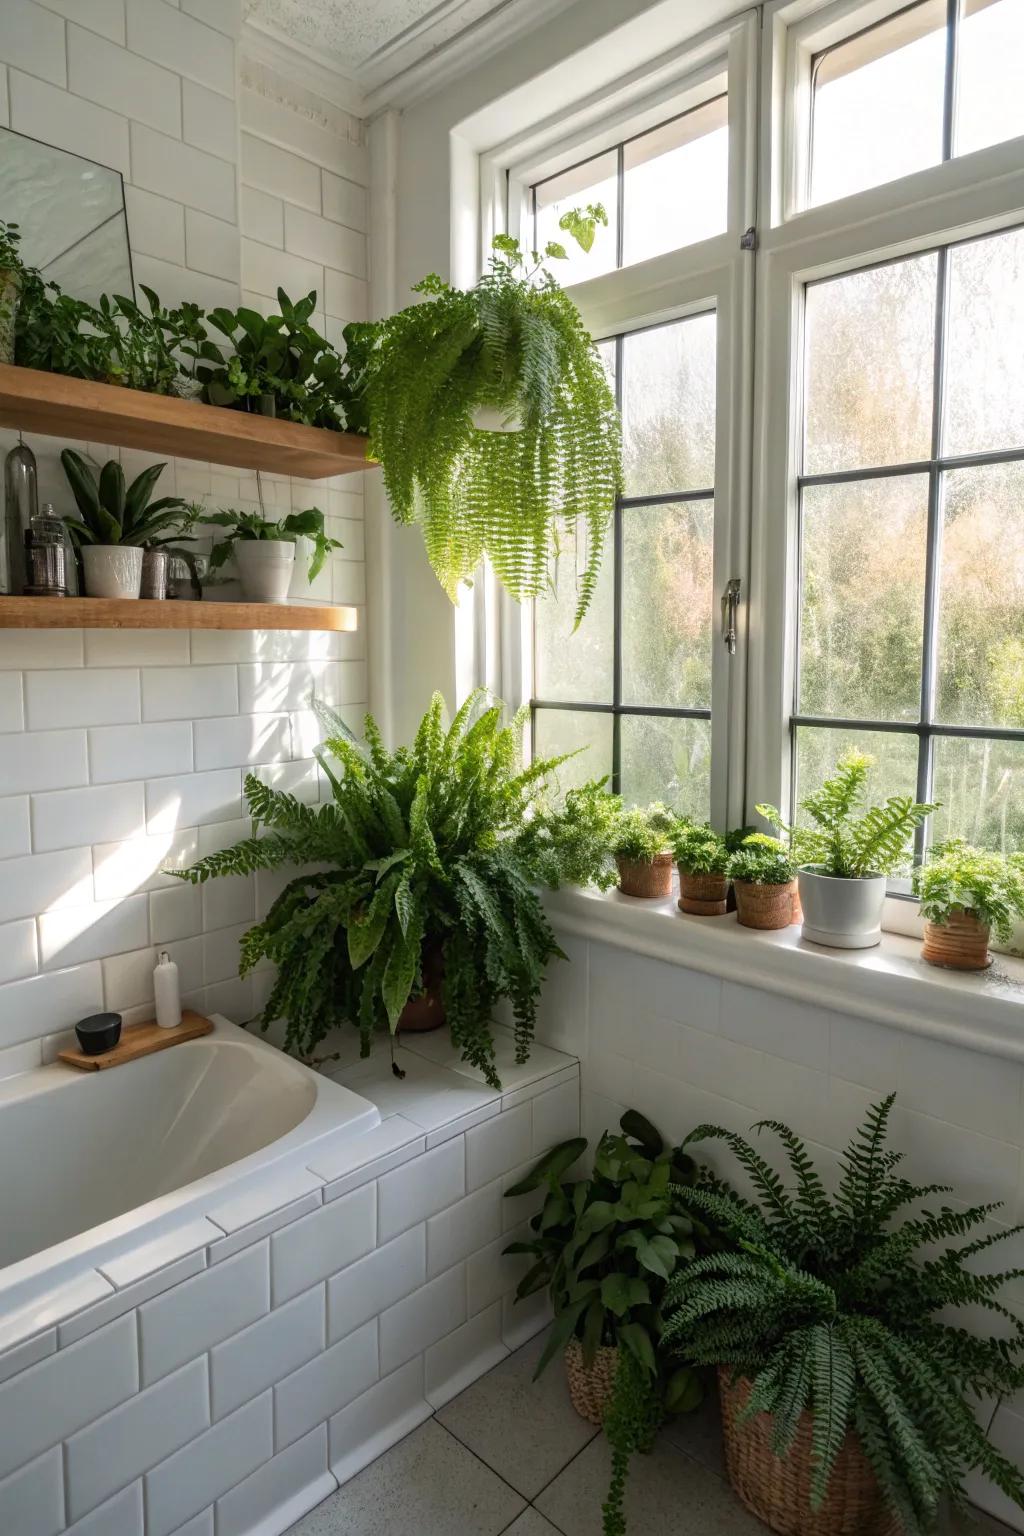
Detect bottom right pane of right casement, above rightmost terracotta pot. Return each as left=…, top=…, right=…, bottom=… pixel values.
left=930, top=736, right=1024, bottom=852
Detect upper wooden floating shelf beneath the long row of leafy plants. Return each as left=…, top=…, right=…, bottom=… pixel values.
left=0, top=364, right=372, bottom=479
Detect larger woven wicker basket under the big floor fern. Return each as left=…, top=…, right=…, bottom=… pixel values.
left=718, top=1367, right=903, bottom=1536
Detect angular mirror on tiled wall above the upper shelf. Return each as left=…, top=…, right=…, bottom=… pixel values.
left=0, top=127, right=135, bottom=304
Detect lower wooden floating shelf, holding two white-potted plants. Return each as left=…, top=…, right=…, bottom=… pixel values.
left=0, top=596, right=359, bottom=631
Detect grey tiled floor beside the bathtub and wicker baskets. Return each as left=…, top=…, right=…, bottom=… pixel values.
left=290, top=1339, right=1012, bottom=1536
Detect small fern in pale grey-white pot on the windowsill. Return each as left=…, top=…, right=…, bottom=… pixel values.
left=757, top=753, right=936, bottom=949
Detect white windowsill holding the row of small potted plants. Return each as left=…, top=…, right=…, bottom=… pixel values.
left=543, top=888, right=1024, bottom=1061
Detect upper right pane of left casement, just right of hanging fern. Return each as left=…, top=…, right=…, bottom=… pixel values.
left=622, top=315, right=715, bottom=496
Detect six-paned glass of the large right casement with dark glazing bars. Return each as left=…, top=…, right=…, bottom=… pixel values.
left=792, top=229, right=1024, bottom=849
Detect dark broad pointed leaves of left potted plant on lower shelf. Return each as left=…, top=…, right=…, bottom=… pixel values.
left=60, top=449, right=190, bottom=548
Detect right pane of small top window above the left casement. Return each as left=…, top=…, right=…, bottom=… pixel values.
left=622, top=97, right=729, bottom=266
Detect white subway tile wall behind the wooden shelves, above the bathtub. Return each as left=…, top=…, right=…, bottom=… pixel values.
left=0, top=0, right=368, bottom=1049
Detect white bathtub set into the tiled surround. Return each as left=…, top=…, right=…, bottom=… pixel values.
left=0, top=1017, right=381, bottom=1339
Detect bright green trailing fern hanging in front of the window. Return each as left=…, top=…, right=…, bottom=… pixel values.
left=353, top=206, right=622, bottom=624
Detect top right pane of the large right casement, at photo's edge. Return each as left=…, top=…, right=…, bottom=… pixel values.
left=944, top=224, right=1024, bottom=453
